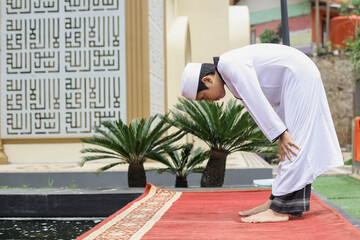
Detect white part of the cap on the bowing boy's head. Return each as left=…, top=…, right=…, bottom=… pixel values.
left=181, top=63, right=202, bottom=100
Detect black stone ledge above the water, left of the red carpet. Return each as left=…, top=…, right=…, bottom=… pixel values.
left=0, top=189, right=143, bottom=217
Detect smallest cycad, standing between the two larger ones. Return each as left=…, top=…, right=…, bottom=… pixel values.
left=155, top=143, right=210, bottom=188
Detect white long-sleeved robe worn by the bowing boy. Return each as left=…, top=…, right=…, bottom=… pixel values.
left=217, top=44, right=343, bottom=196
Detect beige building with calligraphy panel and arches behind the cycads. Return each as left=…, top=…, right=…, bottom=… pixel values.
left=0, top=0, right=250, bottom=164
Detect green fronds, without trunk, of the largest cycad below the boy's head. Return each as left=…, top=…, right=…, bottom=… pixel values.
left=166, top=98, right=271, bottom=153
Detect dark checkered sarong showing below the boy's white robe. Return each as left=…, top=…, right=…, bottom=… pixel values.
left=269, top=184, right=311, bottom=217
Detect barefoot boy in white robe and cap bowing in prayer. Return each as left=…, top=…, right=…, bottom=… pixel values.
left=181, top=44, right=343, bottom=222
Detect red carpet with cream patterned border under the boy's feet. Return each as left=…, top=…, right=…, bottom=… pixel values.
left=78, top=184, right=360, bottom=240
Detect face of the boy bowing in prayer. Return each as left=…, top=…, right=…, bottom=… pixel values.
left=196, top=74, right=225, bottom=102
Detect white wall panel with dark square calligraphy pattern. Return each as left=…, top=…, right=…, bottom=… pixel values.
left=0, top=0, right=126, bottom=138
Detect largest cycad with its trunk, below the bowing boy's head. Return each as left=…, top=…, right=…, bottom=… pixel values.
left=166, top=98, right=274, bottom=187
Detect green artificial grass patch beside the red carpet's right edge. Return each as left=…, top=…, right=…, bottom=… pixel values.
left=312, top=176, right=360, bottom=220
